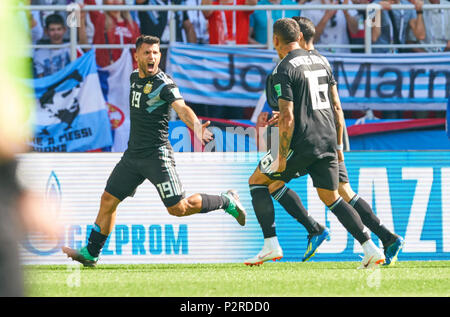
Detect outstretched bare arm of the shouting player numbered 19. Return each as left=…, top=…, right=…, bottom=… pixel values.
left=172, top=99, right=214, bottom=145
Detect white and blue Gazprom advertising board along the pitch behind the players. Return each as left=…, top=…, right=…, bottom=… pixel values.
left=15, top=151, right=450, bottom=264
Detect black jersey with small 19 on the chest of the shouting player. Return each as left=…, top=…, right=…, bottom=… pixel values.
left=127, top=70, right=183, bottom=156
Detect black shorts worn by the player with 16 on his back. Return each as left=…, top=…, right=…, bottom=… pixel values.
left=258, top=150, right=340, bottom=190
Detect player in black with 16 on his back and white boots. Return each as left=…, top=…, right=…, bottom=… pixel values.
left=248, top=18, right=385, bottom=268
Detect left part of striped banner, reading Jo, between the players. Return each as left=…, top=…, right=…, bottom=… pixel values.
left=167, top=43, right=276, bottom=107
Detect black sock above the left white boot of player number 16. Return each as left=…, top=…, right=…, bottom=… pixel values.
left=250, top=185, right=276, bottom=239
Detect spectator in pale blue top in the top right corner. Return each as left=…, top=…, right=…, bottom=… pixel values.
left=407, top=0, right=450, bottom=53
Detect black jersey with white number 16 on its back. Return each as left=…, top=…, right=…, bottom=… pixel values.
left=266, top=49, right=336, bottom=158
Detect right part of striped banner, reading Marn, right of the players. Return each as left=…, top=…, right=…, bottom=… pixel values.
left=325, top=53, right=450, bottom=110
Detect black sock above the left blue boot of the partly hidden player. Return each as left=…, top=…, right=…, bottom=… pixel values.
left=272, top=185, right=324, bottom=235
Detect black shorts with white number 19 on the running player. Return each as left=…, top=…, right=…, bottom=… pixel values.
left=105, top=145, right=185, bottom=207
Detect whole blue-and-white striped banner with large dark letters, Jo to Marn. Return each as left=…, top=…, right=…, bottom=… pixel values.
left=168, top=43, right=450, bottom=110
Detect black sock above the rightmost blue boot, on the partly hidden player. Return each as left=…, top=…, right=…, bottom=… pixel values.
left=349, top=195, right=398, bottom=247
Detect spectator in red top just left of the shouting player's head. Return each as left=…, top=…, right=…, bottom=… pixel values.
left=80, top=0, right=140, bottom=67
